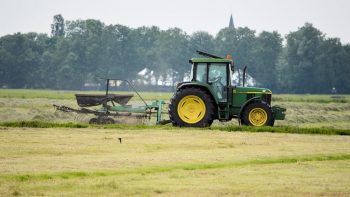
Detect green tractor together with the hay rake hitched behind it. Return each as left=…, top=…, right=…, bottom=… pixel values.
left=55, top=51, right=286, bottom=127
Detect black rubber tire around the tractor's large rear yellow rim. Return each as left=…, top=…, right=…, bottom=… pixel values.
left=169, top=87, right=215, bottom=127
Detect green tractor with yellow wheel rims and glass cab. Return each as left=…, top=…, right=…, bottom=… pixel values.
left=169, top=51, right=286, bottom=127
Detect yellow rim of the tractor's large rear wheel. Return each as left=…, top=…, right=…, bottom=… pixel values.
left=177, top=95, right=206, bottom=124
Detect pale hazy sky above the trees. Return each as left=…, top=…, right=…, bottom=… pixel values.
left=0, top=0, right=350, bottom=44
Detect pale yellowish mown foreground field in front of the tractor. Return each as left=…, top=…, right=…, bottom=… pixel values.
left=0, top=128, right=350, bottom=196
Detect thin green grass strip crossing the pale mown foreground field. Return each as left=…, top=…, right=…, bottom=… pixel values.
left=0, top=154, right=350, bottom=182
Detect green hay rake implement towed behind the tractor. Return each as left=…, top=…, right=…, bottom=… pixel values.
left=54, top=79, right=165, bottom=124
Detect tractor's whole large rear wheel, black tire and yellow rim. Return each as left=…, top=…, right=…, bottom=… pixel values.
left=169, top=87, right=215, bottom=127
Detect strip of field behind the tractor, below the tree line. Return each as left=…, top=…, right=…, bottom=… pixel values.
left=0, top=89, right=350, bottom=129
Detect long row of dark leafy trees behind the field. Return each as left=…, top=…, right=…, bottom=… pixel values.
left=0, top=15, right=350, bottom=93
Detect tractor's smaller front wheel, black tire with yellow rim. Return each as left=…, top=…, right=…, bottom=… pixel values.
left=241, top=101, right=275, bottom=126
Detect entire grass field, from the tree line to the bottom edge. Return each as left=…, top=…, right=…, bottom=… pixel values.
left=0, top=90, right=350, bottom=196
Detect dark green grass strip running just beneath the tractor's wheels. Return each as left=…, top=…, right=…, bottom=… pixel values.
left=0, top=121, right=350, bottom=135
